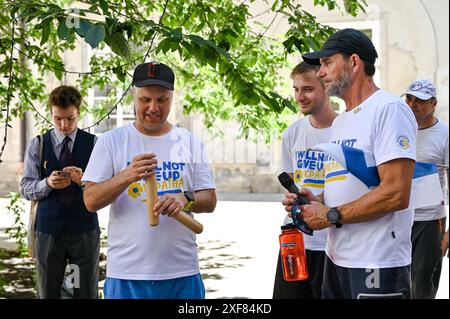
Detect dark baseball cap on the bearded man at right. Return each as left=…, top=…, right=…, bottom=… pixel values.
left=302, top=28, right=378, bottom=65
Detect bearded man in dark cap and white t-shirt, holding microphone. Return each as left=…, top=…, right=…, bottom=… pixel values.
left=283, top=29, right=417, bottom=299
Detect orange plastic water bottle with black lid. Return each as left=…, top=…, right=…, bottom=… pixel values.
left=280, top=224, right=308, bottom=281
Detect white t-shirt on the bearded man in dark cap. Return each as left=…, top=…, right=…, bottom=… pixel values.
left=324, top=90, right=417, bottom=268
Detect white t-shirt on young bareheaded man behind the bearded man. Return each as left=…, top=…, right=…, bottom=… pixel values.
left=281, top=116, right=331, bottom=251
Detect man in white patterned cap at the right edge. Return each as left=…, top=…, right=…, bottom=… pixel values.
left=403, top=80, right=449, bottom=299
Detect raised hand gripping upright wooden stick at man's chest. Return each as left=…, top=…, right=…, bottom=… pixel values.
left=120, top=153, right=158, bottom=185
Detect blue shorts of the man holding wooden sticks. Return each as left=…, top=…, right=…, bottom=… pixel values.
left=103, top=274, right=205, bottom=299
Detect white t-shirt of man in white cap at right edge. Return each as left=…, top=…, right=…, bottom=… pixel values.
left=414, top=121, right=449, bottom=221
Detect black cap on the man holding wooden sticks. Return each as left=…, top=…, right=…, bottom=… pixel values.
left=133, top=61, right=175, bottom=91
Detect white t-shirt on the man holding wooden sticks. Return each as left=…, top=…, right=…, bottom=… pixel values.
left=83, top=124, right=215, bottom=280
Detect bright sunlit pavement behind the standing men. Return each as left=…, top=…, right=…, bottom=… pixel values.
left=0, top=194, right=449, bottom=299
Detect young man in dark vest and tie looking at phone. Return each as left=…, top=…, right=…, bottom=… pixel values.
left=20, top=85, right=100, bottom=299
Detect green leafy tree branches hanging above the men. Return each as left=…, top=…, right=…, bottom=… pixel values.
left=0, top=0, right=367, bottom=162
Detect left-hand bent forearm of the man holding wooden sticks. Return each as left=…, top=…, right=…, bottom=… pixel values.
left=83, top=173, right=131, bottom=212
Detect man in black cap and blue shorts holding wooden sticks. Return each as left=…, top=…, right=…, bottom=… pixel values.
left=83, top=62, right=216, bottom=299
